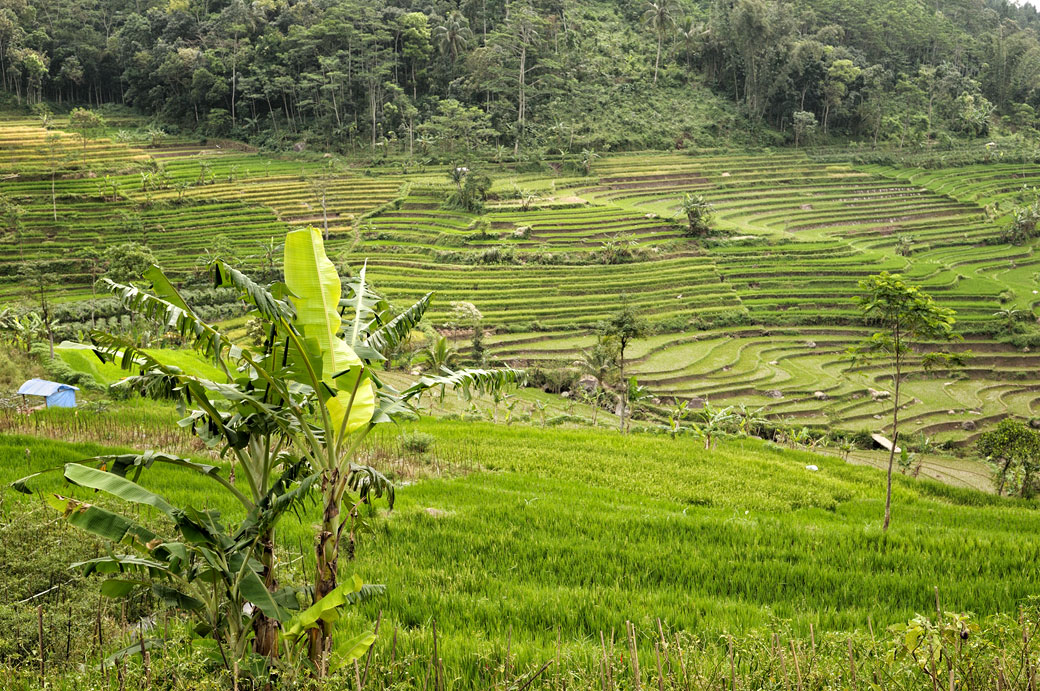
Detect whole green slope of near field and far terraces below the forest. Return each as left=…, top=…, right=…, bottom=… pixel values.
left=6, top=111, right=1040, bottom=678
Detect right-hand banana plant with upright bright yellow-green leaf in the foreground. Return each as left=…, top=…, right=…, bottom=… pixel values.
left=276, top=228, right=521, bottom=663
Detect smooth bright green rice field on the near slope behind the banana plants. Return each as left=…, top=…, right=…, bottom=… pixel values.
left=0, top=410, right=1040, bottom=688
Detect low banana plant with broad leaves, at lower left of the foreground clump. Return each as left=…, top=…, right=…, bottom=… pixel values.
left=15, top=454, right=332, bottom=670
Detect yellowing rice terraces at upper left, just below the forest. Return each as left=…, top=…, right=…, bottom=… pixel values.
left=0, top=119, right=401, bottom=299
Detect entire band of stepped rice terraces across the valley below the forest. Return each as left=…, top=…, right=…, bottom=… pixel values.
left=0, top=116, right=1040, bottom=443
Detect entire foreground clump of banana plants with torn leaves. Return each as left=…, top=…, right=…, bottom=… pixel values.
left=17, top=229, right=518, bottom=674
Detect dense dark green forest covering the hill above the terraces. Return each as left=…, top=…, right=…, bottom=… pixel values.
left=0, top=0, right=1040, bottom=156
